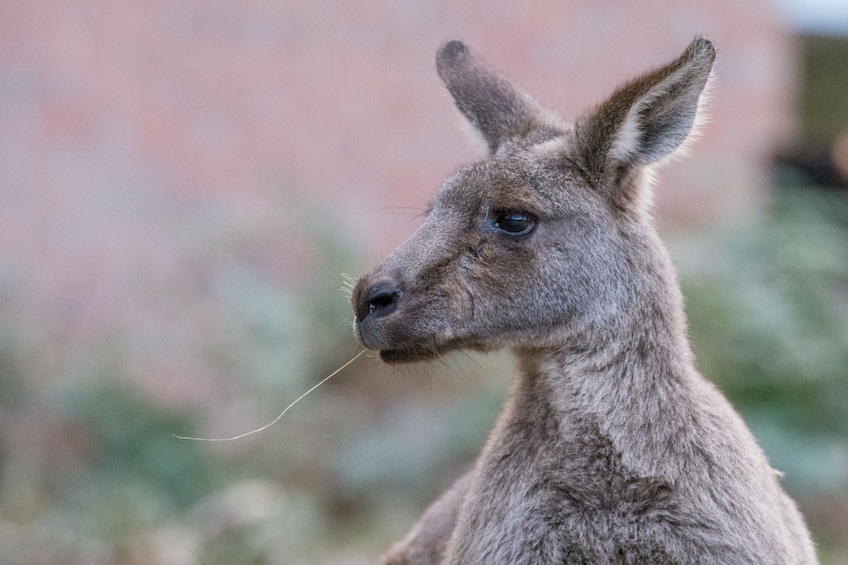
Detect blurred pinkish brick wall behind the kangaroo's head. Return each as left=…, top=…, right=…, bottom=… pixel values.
left=0, top=0, right=796, bottom=396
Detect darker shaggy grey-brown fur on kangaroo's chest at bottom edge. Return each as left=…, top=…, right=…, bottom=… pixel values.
left=452, top=420, right=719, bottom=563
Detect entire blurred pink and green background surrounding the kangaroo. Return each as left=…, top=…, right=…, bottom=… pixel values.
left=0, top=0, right=848, bottom=565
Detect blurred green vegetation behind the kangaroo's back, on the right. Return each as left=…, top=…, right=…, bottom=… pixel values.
left=673, top=171, right=848, bottom=563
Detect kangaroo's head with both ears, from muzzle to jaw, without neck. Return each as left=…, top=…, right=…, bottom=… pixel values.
left=353, top=38, right=715, bottom=362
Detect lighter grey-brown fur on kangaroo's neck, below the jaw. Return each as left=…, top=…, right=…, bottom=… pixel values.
left=510, top=251, right=712, bottom=479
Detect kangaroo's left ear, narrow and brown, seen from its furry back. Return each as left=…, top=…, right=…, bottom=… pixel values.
left=436, top=40, right=545, bottom=153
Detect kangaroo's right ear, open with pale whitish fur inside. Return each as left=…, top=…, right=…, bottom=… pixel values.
left=575, top=37, right=715, bottom=187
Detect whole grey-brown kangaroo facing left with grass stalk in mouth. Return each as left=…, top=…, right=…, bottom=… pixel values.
left=352, top=37, right=817, bottom=565
